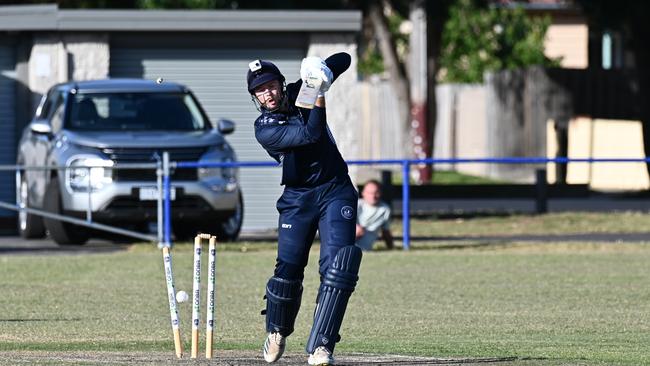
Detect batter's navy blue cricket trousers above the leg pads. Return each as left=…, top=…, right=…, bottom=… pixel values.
left=275, top=176, right=358, bottom=280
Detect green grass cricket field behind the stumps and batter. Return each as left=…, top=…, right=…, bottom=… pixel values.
left=0, top=213, right=650, bottom=365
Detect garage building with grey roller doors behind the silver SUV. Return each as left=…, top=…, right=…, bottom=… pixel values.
left=0, top=5, right=361, bottom=232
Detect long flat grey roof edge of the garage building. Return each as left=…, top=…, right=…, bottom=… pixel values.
left=0, top=4, right=361, bottom=32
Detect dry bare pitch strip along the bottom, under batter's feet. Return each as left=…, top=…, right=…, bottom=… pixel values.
left=0, top=351, right=525, bottom=366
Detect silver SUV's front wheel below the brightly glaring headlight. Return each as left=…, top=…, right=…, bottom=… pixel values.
left=43, top=177, right=89, bottom=245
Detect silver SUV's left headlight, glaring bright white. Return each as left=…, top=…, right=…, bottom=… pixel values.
left=66, top=157, right=113, bottom=192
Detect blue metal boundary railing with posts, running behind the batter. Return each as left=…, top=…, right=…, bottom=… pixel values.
left=163, top=157, right=650, bottom=250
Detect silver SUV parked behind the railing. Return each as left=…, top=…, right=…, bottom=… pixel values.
left=16, top=79, right=243, bottom=244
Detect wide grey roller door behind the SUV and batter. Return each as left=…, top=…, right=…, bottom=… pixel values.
left=110, top=45, right=305, bottom=231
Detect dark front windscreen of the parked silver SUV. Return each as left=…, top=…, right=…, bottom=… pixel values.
left=65, top=93, right=209, bottom=131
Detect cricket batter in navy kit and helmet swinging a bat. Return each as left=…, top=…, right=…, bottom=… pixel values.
left=247, top=53, right=361, bottom=365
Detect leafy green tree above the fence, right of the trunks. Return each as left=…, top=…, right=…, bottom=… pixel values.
left=439, top=0, right=558, bottom=83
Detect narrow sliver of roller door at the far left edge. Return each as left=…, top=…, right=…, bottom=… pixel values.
left=0, top=45, right=16, bottom=217
